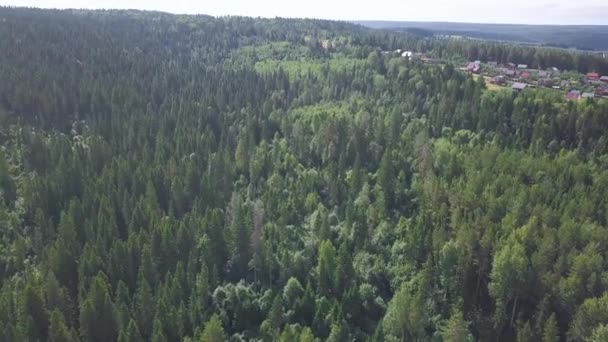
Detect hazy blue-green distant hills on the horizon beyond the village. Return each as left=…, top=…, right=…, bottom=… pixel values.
left=356, top=21, right=608, bottom=51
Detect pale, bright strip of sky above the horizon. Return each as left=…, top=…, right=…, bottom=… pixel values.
left=0, top=0, right=608, bottom=25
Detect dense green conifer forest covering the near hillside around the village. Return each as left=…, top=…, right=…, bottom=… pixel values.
left=0, top=8, right=608, bottom=342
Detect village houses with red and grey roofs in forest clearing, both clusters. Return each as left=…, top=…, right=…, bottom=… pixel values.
left=383, top=49, right=608, bottom=101
